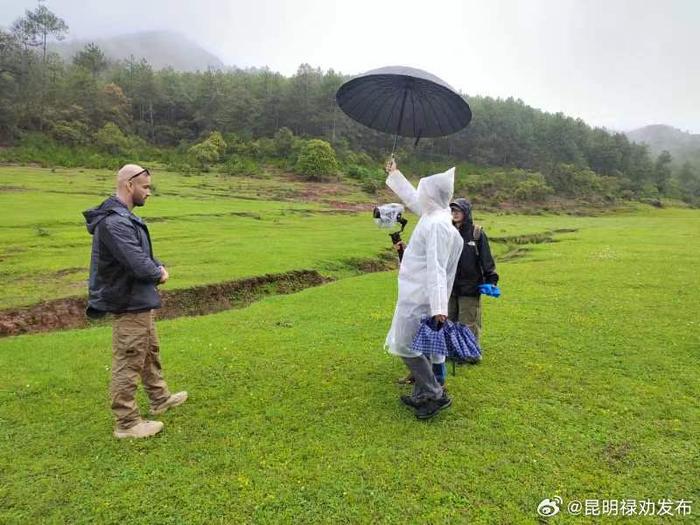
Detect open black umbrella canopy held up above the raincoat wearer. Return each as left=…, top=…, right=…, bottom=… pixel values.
left=335, top=66, right=472, bottom=138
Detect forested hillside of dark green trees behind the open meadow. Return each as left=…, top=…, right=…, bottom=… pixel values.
left=0, top=5, right=700, bottom=203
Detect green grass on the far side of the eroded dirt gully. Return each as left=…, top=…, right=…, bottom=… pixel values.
left=0, top=167, right=589, bottom=309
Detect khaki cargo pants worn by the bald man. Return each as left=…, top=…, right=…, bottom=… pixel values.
left=110, top=310, right=170, bottom=429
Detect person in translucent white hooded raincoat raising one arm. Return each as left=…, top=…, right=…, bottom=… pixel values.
left=385, top=160, right=464, bottom=419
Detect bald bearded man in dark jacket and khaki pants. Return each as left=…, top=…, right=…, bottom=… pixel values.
left=83, top=164, right=187, bottom=439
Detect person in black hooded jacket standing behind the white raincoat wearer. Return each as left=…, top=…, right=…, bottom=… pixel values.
left=448, top=199, right=498, bottom=341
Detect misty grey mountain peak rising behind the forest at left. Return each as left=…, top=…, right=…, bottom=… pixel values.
left=51, top=31, right=224, bottom=71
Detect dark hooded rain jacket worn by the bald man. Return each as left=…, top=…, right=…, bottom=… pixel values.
left=83, top=196, right=161, bottom=318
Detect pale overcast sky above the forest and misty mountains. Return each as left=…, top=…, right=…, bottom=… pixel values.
left=0, top=0, right=700, bottom=133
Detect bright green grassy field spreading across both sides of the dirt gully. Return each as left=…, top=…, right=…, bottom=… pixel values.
left=0, top=169, right=700, bottom=524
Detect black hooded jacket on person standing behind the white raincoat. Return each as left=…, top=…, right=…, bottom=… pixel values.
left=450, top=199, right=498, bottom=297
